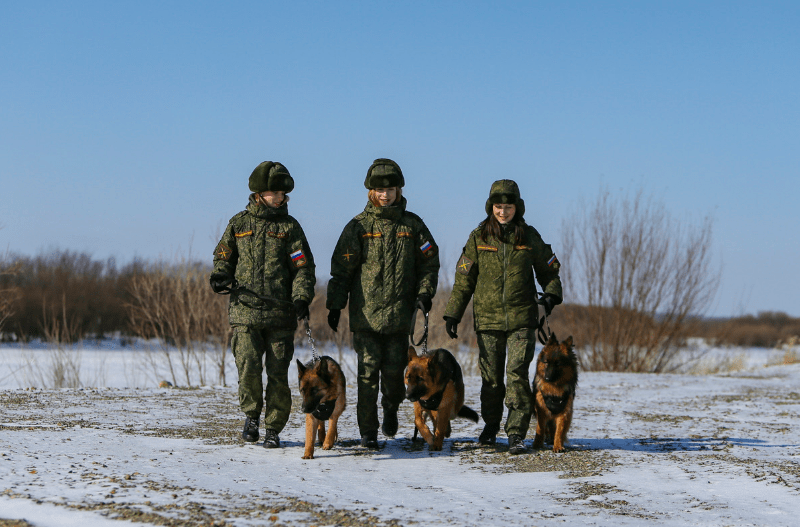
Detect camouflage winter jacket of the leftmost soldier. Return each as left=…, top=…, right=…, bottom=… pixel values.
left=214, top=196, right=316, bottom=329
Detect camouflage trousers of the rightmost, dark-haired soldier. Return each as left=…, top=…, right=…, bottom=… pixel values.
left=477, top=328, right=536, bottom=437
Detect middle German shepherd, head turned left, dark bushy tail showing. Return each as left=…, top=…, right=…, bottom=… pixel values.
left=405, top=346, right=478, bottom=450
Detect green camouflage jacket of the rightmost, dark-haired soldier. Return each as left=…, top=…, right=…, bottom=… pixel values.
left=444, top=225, right=562, bottom=331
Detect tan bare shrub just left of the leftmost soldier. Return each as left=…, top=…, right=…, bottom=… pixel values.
left=127, top=259, right=230, bottom=386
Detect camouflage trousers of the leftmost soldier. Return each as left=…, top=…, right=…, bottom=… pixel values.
left=231, top=326, right=294, bottom=432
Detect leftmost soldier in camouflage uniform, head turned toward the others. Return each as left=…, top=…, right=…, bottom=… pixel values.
left=211, top=161, right=316, bottom=448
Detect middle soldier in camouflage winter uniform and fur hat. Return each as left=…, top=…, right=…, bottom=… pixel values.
left=327, top=159, right=439, bottom=449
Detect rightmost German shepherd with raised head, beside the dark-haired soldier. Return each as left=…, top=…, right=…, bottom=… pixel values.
left=533, top=333, right=578, bottom=452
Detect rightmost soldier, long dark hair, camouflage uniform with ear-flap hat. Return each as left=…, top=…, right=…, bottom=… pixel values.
left=444, top=179, right=562, bottom=453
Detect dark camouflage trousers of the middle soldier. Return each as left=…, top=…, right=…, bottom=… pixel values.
left=353, top=332, right=408, bottom=436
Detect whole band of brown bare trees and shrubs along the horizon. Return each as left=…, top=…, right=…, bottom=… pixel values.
left=0, top=188, right=800, bottom=372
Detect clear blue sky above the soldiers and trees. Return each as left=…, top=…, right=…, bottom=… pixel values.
left=0, top=1, right=800, bottom=316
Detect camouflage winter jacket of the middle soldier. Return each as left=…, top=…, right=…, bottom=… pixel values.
left=327, top=196, right=439, bottom=334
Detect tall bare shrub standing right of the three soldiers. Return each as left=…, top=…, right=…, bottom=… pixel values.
left=561, top=188, right=721, bottom=372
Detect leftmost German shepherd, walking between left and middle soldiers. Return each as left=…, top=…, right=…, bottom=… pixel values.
left=297, top=355, right=347, bottom=459
